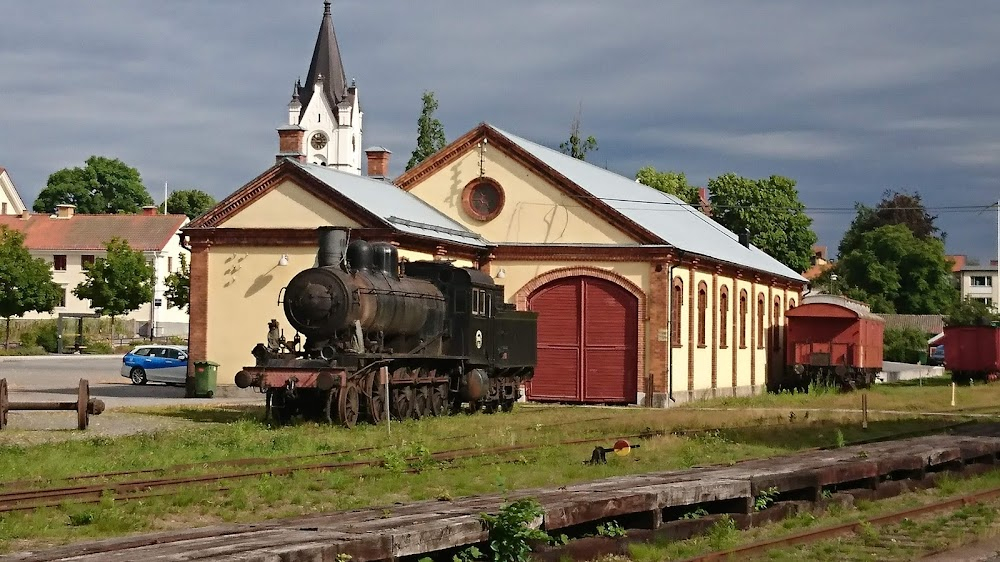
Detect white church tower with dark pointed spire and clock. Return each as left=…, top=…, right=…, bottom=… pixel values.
left=278, top=0, right=362, bottom=175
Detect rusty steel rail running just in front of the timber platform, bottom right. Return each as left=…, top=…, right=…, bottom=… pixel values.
left=683, top=488, right=1000, bottom=562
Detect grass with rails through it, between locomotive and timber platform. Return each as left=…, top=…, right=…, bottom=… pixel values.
left=0, top=385, right=1000, bottom=552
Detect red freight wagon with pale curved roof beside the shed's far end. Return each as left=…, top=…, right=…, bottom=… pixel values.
left=782, top=295, right=885, bottom=390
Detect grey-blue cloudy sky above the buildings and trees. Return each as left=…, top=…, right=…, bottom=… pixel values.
left=0, top=0, right=1000, bottom=258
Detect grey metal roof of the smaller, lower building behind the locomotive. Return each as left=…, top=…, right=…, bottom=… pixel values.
left=289, top=160, right=489, bottom=248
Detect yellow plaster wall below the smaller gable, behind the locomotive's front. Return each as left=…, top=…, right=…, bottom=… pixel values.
left=206, top=246, right=430, bottom=384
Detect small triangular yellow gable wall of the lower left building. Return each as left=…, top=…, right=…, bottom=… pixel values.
left=220, top=181, right=361, bottom=228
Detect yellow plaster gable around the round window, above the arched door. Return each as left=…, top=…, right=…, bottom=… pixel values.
left=411, top=147, right=634, bottom=244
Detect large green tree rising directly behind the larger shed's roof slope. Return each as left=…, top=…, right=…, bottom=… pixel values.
left=708, top=173, right=818, bottom=272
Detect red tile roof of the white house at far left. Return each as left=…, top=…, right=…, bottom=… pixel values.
left=0, top=214, right=187, bottom=251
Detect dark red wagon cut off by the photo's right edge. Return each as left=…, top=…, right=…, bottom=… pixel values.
left=944, top=326, right=1000, bottom=383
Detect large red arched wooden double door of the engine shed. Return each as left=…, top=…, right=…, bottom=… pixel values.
left=528, top=277, right=638, bottom=403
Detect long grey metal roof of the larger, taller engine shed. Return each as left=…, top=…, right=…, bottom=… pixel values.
left=490, top=125, right=808, bottom=283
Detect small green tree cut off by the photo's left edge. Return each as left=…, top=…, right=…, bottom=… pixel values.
left=0, top=226, right=62, bottom=349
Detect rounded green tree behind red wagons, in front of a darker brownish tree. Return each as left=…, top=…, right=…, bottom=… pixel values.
left=833, top=224, right=959, bottom=314
